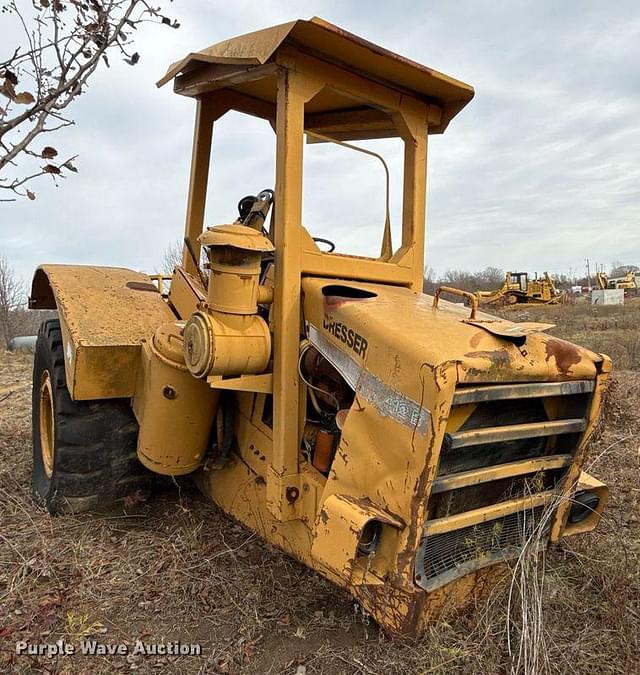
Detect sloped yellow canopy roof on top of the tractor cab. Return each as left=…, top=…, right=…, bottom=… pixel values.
left=158, top=17, right=474, bottom=133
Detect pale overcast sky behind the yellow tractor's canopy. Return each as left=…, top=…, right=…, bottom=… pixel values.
left=0, top=0, right=640, bottom=286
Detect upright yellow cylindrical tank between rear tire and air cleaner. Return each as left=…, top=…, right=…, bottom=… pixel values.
left=133, top=322, right=220, bottom=476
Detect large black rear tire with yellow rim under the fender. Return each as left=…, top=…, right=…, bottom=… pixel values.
left=31, top=319, right=152, bottom=515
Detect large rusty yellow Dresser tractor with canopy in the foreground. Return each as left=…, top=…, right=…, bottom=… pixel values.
left=30, top=18, right=611, bottom=634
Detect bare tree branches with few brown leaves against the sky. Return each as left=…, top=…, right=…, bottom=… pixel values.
left=0, top=0, right=179, bottom=201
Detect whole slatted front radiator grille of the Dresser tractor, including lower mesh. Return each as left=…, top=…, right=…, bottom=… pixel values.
left=415, top=380, right=594, bottom=590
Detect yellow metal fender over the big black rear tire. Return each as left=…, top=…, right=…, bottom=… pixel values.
left=30, top=265, right=175, bottom=400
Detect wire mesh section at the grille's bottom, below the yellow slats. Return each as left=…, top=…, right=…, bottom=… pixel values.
left=416, top=506, right=548, bottom=590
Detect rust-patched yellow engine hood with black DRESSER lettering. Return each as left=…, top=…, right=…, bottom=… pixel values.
left=303, top=278, right=603, bottom=388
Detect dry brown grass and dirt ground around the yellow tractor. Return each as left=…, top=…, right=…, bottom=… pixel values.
left=0, top=303, right=640, bottom=675
